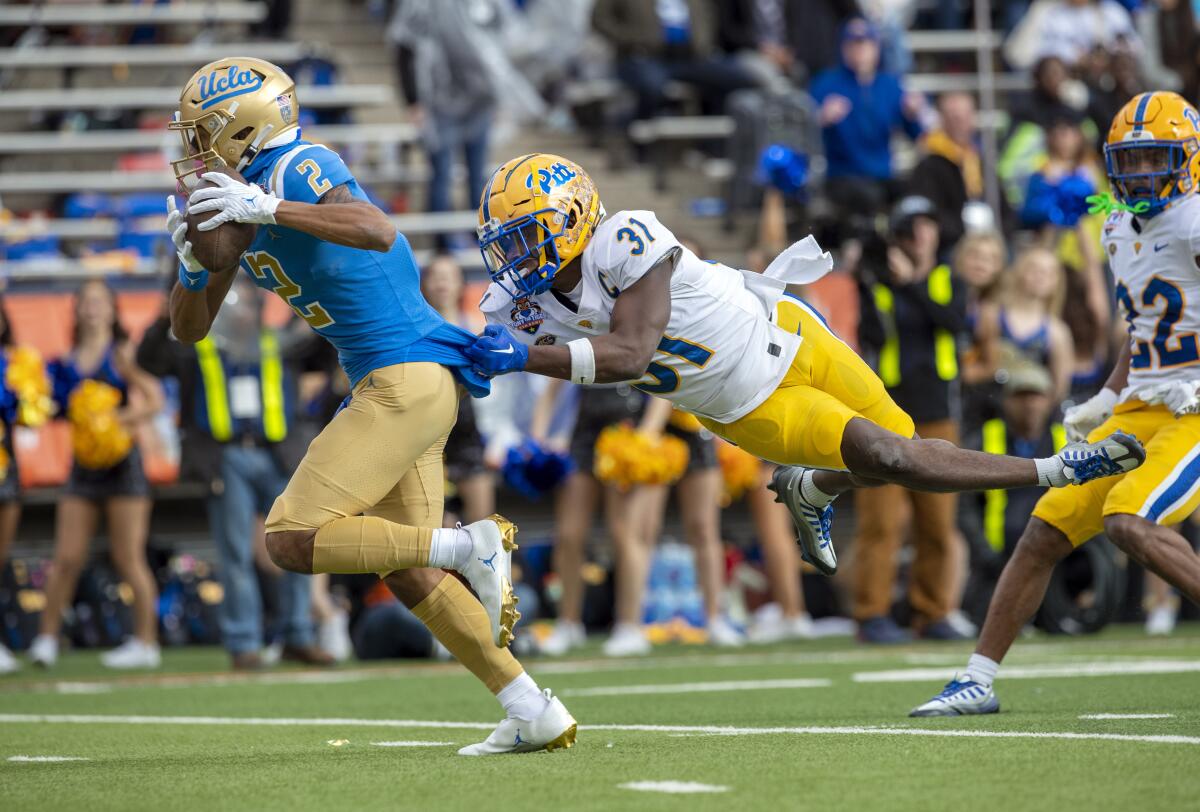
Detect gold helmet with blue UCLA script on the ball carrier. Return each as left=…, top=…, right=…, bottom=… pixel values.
left=167, top=56, right=300, bottom=184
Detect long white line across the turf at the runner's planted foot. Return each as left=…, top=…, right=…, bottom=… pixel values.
left=0, top=714, right=1200, bottom=746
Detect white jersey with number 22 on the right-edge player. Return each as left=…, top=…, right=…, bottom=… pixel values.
left=1103, top=194, right=1200, bottom=399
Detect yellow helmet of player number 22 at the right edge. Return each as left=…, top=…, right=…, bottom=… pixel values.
left=1104, top=91, right=1200, bottom=217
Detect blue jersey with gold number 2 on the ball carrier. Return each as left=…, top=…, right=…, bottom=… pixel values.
left=241, top=140, right=487, bottom=397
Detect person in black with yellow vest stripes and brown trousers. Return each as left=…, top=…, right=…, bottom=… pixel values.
left=854, top=197, right=966, bottom=643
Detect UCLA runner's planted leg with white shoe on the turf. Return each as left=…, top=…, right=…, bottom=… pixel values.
left=371, top=438, right=575, bottom=754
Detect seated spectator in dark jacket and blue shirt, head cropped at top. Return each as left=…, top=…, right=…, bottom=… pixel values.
left=592, top=0, right=755, bottom=120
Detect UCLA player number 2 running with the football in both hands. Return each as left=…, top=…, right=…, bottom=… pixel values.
left=168, top=58, right=576, bottom=754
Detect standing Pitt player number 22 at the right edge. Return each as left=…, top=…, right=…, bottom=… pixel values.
left=911, top=91, right=1200, bottom=716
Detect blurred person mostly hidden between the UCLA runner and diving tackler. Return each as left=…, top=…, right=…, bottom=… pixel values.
left=421, top=254, right=496, bottom=523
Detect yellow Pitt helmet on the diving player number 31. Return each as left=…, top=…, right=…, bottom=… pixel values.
left=479, top=152, right=605, bottom=299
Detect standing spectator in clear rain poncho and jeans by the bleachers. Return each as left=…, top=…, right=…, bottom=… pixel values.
left=388, top=0, right=545, bottom=238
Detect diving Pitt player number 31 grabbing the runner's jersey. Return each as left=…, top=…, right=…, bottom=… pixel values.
left=466, top=154, right=1144, bottom=573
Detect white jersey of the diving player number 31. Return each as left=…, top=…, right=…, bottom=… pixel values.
left=480, top=211, right=800, bottom=423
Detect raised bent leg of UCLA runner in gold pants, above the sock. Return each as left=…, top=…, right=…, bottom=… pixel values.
left=266, top=363, right=458, bottom=572
